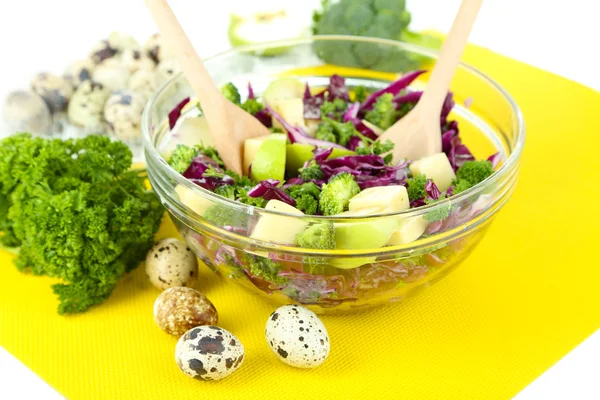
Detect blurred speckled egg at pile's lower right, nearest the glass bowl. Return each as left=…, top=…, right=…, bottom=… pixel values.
left=104, top=90, right=146, bottom=142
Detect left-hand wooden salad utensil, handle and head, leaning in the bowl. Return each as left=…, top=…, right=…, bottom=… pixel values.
left=145, top=0, right=270, bottom=175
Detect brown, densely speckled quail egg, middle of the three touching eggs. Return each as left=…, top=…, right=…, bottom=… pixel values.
left=154, top=286, right=219, bottom=337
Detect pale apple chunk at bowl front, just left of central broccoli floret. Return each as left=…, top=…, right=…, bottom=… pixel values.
left=250, top=200, right=307, bottom=245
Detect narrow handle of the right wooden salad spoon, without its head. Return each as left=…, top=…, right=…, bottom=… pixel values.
left=419, top=0, right=483, bottom=118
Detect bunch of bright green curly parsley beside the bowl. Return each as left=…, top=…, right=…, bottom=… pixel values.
left=0, top=134, right=164, bottom=314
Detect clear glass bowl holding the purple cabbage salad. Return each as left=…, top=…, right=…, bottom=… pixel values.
left=142, top=36, right=525, bottom=313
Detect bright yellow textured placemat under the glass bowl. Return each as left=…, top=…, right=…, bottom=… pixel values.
left=0, top=43, right=600, bottom=400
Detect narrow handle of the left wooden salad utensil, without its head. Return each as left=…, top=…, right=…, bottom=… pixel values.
left=145, top=0, right=222, bottom=107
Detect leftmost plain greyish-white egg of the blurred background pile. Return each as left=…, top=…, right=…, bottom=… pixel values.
left=2, top=90, right=52, bottom=135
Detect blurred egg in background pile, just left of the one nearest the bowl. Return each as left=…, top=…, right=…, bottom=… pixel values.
left=67, top=81, right=110, bottom=129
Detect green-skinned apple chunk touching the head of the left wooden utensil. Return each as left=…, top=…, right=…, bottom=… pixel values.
left=250, top=134, right=287, bottom=181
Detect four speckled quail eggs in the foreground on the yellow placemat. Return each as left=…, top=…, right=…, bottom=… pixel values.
left=145, top=238, right=330, bottom=381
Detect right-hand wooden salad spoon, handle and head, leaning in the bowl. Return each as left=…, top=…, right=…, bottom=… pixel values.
left=379, top=0, right=483, bottom=163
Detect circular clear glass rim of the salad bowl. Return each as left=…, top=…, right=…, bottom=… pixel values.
left=142, top=35, right=526, bottom=222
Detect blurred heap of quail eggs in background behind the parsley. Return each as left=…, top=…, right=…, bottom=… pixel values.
left=3, top=32, right=180, bottom=153
